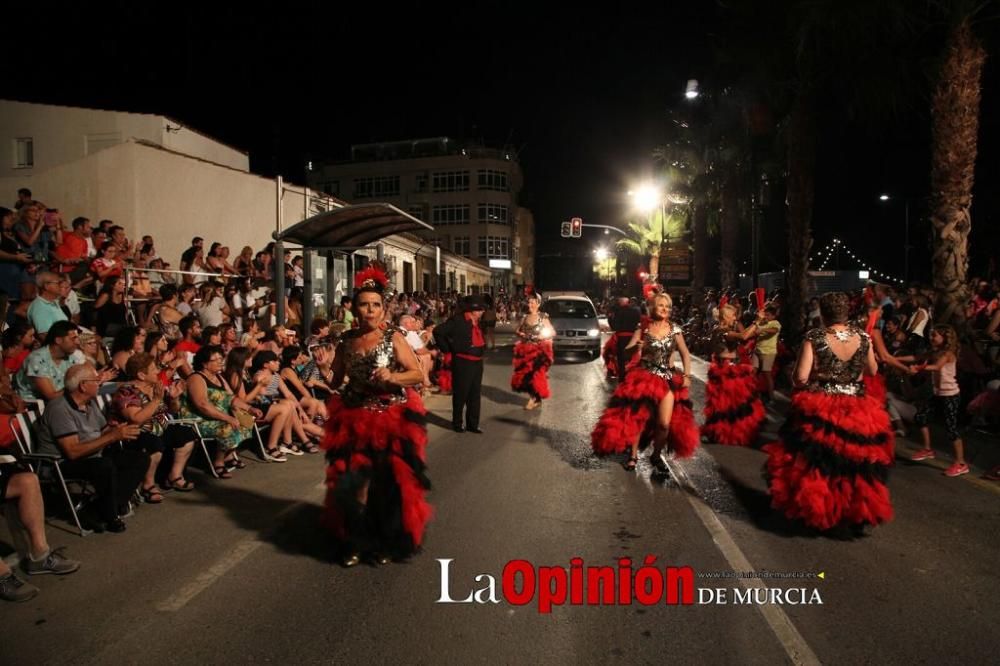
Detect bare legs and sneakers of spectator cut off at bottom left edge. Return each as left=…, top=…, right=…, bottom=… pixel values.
left=0, top=465, right=80, bottom=601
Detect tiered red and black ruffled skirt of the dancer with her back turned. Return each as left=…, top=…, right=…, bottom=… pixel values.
left=764, top=391, right=895, bottom=530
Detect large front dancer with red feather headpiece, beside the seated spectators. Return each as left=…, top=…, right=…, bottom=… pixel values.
left=322, top=268, right=431, bottom=566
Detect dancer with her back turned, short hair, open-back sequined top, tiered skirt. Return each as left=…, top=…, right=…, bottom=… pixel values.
left=764, top=293, right=894, bottom=531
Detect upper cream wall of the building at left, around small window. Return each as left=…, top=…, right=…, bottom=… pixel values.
left=0, top=100, right=250, bottom=178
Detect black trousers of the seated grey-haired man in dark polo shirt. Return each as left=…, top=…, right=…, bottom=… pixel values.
left=59, top=444, right=149, bottom=523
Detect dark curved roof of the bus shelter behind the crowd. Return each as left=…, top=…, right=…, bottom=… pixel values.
left=274, top=203, right=434, bottom=249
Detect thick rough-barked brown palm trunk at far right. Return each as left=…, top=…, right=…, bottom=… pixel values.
left=931, top=20, right=986, bottom=327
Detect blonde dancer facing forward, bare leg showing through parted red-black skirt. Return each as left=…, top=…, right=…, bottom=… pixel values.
left=590, top=294, right=698, bottom=472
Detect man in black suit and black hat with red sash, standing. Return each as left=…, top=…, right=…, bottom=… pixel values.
left=434, top=296, right=486, bottom=434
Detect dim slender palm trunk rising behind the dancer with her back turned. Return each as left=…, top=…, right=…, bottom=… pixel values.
left=782, top=83, right=816, bottom=341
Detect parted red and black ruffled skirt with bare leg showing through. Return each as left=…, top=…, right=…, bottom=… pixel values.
left=590, top=366, right=698, bottom=458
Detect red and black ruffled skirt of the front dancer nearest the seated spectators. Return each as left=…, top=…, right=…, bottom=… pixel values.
left=322, top=389, right=433, bottom=557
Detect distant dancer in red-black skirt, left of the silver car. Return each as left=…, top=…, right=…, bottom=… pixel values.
left=510, top=294, right=555, bottom=409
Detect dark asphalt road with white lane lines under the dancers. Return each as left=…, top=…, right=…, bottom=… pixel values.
left=0, top=334, right=1000, bottom=664
